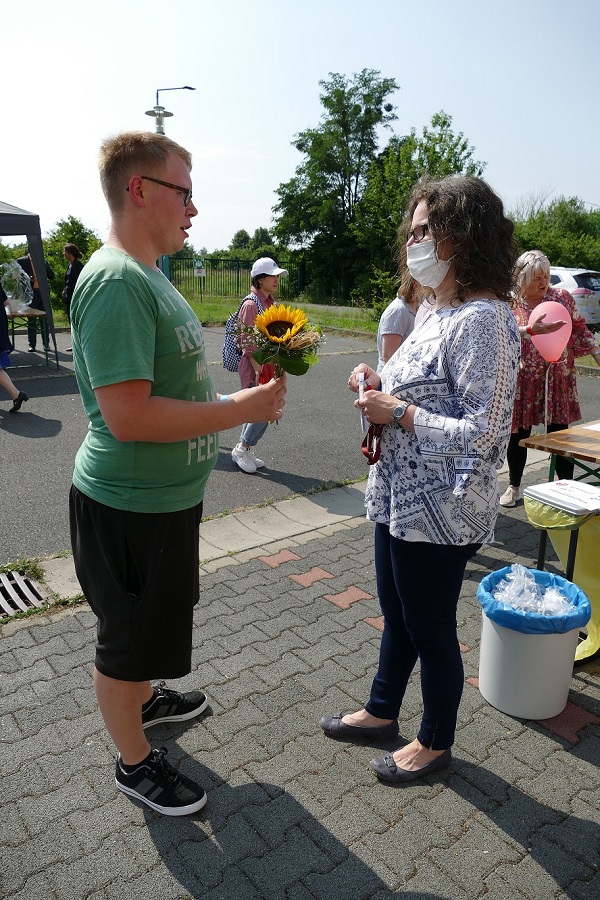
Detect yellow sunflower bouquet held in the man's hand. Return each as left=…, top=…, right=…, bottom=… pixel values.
left=241, top=303, right=323, bottom=376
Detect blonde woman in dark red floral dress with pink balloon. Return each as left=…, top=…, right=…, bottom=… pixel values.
left=500, top=250, right=600, bottom=506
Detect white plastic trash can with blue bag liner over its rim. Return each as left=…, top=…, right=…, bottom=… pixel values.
left=477, top=566, right=591, bottom=719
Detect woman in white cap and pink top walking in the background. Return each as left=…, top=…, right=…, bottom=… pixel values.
left=231, top=256, right=288, bottom=473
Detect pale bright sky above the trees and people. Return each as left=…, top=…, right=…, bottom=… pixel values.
left=0, top=0, right=600, bottom=251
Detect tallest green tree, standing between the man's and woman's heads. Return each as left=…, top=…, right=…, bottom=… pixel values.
left=274, top=69, right=398, bottom=297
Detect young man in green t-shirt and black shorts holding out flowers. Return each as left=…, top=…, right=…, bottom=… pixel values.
left=70, top=132, right=286, bottom=816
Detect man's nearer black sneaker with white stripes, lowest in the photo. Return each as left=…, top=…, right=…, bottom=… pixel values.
left=115, top=747, right=206, bottom=816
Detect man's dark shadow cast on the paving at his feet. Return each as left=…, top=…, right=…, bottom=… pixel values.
left=144, top=759, right=443, bottom=900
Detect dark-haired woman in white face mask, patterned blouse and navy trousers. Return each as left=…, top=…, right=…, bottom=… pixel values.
left=321, top=176, right=520, bottom=782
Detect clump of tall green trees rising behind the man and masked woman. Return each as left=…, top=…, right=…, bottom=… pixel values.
left=274, top=69, right=484, bottom=299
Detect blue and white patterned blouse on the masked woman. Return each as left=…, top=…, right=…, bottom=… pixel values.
left=365, top=299, right=521, bottom=544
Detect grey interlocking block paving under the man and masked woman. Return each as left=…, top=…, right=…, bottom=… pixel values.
left=0, top=461, right=600, bottom=900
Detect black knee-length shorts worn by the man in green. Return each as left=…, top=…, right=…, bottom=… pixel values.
left=69, top=485, right=202, bottom=681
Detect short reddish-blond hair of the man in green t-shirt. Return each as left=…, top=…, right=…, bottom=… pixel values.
left=98, top=131, right=192, bottom=213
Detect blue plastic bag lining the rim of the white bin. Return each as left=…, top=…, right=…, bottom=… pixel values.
left=476, top=566, right=592, bottom=634
